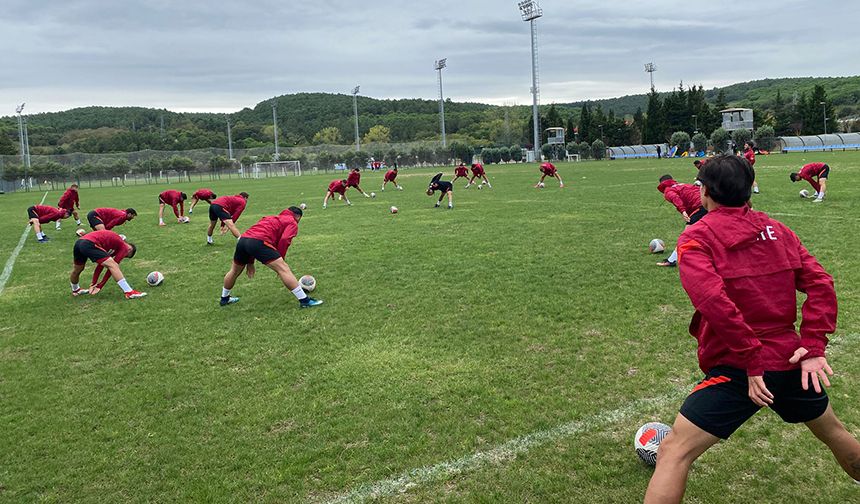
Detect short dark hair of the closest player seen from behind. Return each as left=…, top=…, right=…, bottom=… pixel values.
left=696, top=154, right=755, bottom=207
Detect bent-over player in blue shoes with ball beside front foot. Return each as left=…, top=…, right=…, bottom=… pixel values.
left=221, top=207, right=322, bottom=308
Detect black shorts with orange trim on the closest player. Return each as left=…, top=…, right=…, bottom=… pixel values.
left=681, top=366, right=829, bottom=439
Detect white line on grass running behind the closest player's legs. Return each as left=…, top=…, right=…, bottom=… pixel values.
left=325, top=333, right=860, bottom=504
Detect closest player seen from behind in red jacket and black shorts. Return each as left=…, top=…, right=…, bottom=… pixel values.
left=645, top=156, right=860, bottom=504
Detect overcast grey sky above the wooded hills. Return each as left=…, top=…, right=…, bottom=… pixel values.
left=0, top=0, right=860, bottom=116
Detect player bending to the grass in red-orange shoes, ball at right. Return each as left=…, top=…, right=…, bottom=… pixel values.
left=69, top=230, right=146, bottom=299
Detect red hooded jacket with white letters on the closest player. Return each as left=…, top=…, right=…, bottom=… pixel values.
left=678, top=206, right=837, bottom=376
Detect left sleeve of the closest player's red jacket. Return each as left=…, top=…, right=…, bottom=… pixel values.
left=678, top=236, right=764, bottom=376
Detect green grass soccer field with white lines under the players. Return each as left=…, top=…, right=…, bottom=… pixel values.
left=0, top=153, right=860, bottom=503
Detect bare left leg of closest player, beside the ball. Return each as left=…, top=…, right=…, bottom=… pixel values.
left=645, top=414, right=720, bottom=504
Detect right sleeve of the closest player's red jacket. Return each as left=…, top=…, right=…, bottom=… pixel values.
left=794, top=234, right=837, bottom=359
